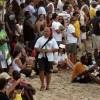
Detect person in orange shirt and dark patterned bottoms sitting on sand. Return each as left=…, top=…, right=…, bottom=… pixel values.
left=71, top=56, right=100, bottom=84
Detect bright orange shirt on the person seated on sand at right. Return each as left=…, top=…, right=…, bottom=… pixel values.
left=72, top=62, right=86, bottom=81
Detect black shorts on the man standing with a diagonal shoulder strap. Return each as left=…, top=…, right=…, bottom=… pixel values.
left=38, top=59, right=53, bottom=73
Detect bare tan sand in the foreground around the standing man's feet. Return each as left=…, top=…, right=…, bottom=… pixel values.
left=28, top=72, right=100, bottom=100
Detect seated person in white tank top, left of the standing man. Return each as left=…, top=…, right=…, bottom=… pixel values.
left=12, top=48, right=32, bottom=77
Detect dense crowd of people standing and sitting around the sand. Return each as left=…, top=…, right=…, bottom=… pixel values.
left=0, top=0, right=100, bottom=100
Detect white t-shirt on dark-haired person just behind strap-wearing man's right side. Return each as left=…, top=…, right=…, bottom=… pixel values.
left=52, top=21, right=62, bottom=41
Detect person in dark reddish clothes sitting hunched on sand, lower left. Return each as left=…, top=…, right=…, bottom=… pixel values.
left=9, top=71, right=36, bottom=100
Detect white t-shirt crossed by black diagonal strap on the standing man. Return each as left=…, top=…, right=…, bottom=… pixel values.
left=35, top=36, right=58, bottom=61
